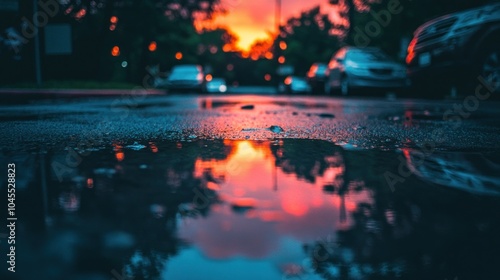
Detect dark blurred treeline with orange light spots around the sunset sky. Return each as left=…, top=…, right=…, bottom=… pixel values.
left=0, top=0, right=493, bottom=86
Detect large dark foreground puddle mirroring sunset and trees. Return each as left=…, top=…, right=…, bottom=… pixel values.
left=0, top=140, right=500, bottom=280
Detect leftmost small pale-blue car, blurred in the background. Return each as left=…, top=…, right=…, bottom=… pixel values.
left=167, top=64, right=206, bottom=92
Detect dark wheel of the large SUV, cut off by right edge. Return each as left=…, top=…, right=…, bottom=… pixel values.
left=479, top=43, right=500, bottom=94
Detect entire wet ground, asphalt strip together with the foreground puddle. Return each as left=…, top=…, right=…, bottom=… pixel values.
left=0, top=91, right=500, bottom=280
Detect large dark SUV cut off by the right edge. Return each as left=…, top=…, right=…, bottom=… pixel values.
left=406, top=2, right=500, bottom=95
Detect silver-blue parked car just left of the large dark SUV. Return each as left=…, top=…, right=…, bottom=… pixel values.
left=325, top=47, right=409, bottom=95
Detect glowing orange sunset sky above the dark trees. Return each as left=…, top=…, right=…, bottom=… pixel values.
left=201, top=0, right=342, bottom=50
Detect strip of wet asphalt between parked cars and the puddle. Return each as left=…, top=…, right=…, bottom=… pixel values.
left=0, top=94, right=500, bottom=151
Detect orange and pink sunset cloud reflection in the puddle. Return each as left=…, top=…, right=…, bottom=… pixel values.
left=174, top=141, right=371, bottom=272
